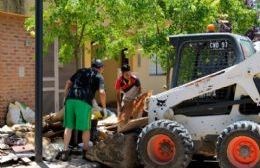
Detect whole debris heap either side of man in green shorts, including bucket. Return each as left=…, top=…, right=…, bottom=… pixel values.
left=0, top=92, right=151, bottom=168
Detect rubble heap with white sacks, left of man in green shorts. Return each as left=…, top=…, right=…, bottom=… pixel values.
left=0, top=101, right=63, bottom=164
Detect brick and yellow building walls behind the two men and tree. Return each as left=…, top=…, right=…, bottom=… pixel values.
left=0, top=0, right=166, bottom=126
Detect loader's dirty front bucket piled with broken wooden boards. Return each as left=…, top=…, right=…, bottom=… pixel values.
left=86, top=92, right=151, bottom=168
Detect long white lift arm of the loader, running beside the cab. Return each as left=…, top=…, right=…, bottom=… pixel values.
left=147, top=52, right=260, bottom=120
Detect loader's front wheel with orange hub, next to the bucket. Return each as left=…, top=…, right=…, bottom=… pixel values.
left=137, top=120, right=194, bottom=168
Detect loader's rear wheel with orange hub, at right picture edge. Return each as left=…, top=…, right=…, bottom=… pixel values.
left=216, top=121, right=260, bottom=168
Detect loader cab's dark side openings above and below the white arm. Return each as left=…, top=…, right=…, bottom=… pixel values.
left=173, top=39, right=236, bottom=116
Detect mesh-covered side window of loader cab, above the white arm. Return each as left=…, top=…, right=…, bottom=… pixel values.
left=177, top=39, right=235, bottom=86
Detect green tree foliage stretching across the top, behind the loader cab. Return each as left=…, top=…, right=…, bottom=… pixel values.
left=26, top=0, right=256, bottom=71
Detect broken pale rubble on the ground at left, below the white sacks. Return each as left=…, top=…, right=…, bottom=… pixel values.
left=0, top=124, right=63, bottom=163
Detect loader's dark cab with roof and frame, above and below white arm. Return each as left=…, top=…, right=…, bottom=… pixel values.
left=169, top=33, right=260, bottom=116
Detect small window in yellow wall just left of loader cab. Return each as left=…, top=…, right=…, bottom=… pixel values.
left=149, top=54, right=165, bottom=75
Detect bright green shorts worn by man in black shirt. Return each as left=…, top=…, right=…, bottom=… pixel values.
left=63, top=99, right=92, bottom=131
